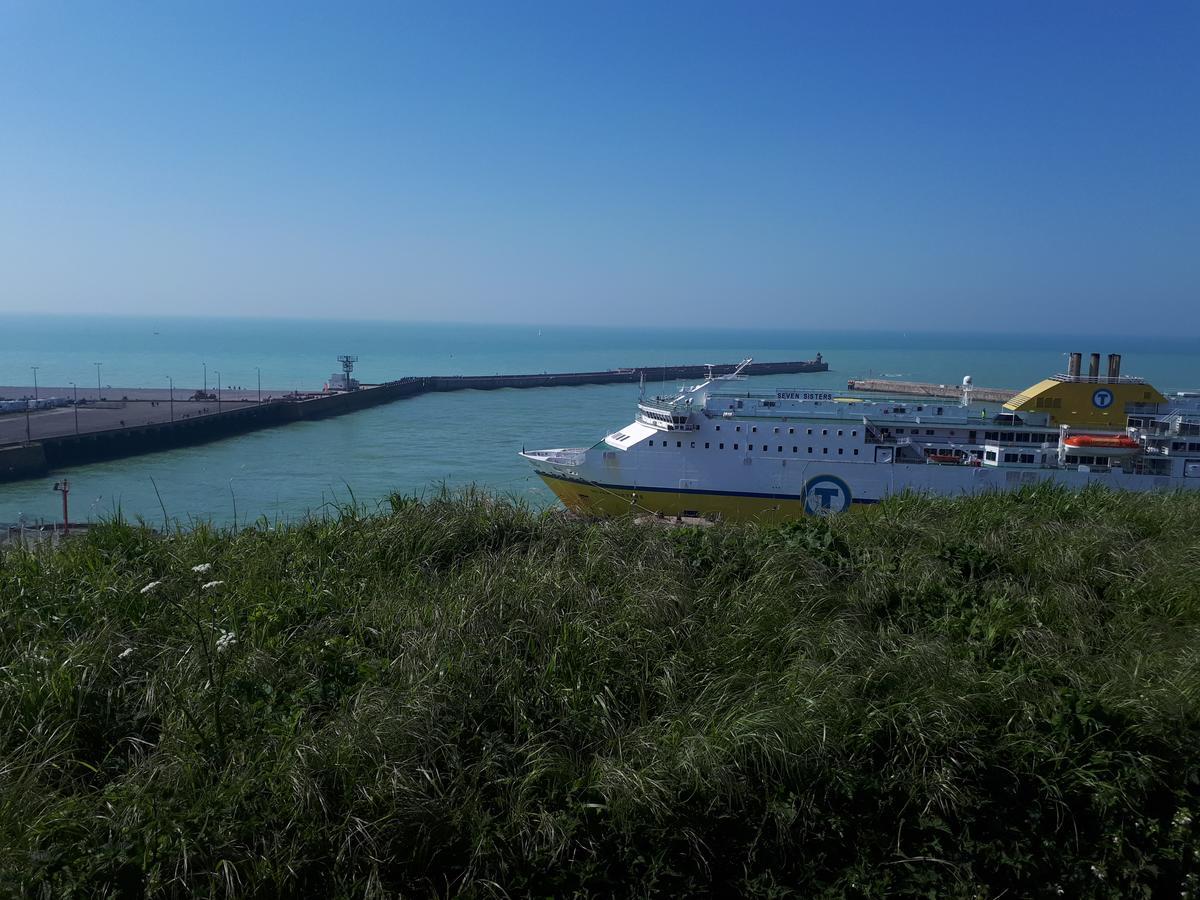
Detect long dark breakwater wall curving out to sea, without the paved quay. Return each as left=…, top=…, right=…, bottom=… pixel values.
left=0, top=354, right=829, bottom=481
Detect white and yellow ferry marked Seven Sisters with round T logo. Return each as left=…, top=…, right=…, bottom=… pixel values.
left=521, top=353, right=1200, bottom=521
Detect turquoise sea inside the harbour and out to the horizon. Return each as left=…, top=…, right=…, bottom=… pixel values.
left=0, top=316, right=1200, bottom=527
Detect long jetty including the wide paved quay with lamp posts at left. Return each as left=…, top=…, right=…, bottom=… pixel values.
left=0, top=354, right=829, bottom=481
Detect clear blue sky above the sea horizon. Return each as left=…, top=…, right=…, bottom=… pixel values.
left=0, top=0, right=1200, bottom=336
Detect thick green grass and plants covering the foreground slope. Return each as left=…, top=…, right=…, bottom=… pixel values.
left=0, top=490, right=1200, bottom=898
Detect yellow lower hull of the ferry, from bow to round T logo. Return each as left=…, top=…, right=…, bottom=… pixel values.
left=538, top=472, right=805, bottom=522
